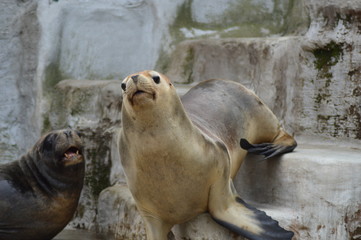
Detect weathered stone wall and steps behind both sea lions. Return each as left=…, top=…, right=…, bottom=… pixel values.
left=0, top=0, right=361, bottom=239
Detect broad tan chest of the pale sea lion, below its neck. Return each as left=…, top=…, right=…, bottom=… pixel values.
left=122, top=126, right=221, bottom=219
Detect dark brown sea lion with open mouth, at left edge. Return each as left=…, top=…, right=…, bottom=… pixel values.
left=0, top=130, right=85, bottom=240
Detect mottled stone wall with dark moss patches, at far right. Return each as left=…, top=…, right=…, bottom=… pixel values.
left=298, top=1, right=361, bottom=139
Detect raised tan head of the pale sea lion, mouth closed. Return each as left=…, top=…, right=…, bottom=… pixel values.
left=121, top=70, right=175, bottom=109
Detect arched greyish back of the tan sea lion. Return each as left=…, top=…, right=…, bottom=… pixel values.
left=182, top=79, right=278, bottom=147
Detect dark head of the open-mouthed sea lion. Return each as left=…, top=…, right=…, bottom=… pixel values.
left=33, top=129, right=84, bottom=168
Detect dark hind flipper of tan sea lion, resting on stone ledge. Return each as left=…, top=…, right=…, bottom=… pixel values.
left=240, top=138, right=297, bottom=159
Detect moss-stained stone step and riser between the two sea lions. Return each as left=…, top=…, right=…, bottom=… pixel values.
left=44, top=80, right=125, bottom=229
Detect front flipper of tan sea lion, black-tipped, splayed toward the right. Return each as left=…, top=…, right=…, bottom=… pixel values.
left=211, top=197, right=294, bottom=240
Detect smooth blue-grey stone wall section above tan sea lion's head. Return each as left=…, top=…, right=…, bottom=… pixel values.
left=39, top=0, right=180, bottom=81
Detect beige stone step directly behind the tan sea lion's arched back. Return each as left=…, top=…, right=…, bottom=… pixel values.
left=167, top=37, right=301, bottom=132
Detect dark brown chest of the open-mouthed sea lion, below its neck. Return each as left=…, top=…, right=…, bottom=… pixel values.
left=0, top=162, right=80, bottom=232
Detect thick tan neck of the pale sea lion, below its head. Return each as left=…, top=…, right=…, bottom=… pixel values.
left=122, top=96, right=201, bottom=154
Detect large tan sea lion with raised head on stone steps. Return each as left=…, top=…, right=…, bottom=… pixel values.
left=119, top=71, right=297, bottom=240
